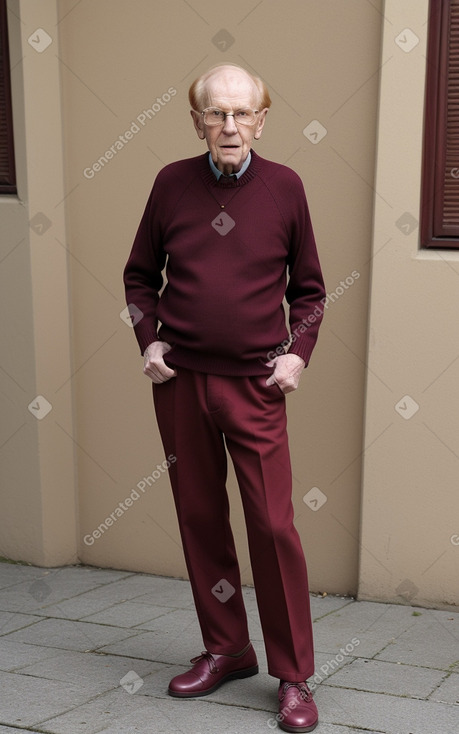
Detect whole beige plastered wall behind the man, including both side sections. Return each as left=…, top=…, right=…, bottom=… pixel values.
left=0, top=0, right=459, bottom=603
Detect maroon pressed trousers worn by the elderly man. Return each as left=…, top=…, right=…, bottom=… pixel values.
left=153, top=368, right=314, bottom=681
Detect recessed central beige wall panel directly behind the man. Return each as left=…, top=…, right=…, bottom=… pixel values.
left=54, top=0, right=380, bottom=592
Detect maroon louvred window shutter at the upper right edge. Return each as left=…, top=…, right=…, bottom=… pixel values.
left=421, top=0, right=459, bottom=248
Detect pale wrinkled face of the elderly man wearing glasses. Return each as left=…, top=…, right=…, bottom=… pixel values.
left=191, top=69, right=267, bottom=175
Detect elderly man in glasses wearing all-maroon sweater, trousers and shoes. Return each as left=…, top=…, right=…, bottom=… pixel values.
left=124, top=64, right=325, bottom=732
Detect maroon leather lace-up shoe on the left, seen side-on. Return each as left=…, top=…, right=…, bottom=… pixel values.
left=167, top=643, right=258, bottom=698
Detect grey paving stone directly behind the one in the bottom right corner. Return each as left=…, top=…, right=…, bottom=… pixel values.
left=327, top=659, right=445, bottom=698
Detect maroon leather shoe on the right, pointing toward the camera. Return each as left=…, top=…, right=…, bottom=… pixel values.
left=276, top=681, right=319, bottom=732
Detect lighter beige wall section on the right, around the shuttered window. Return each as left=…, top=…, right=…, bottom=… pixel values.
left=360, top=0, right=459, bottom=605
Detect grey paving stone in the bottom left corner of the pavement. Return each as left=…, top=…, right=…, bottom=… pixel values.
left=0, top=672, right=97, bottom=727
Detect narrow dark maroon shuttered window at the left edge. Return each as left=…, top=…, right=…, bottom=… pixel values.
left=0, top=0, right=16, bottom=194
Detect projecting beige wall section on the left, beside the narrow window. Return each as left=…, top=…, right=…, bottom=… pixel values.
left=0, top=1, right=77, bottom=565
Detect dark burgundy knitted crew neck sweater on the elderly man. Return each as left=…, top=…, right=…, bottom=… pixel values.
left=124, top=150, right=325, bottom=377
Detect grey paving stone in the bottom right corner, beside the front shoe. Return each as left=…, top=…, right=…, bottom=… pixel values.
left=315, top=685, right=459, bottom=734
